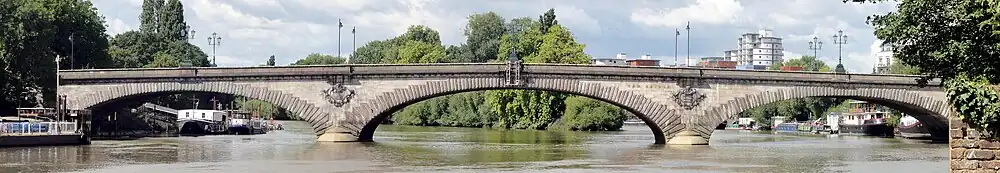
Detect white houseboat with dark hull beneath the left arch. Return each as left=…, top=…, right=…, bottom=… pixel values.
left=177, top=109, right=229, bottom=136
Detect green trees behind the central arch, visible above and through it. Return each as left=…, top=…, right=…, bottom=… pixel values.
left=386, top=10, right=627, bottom=130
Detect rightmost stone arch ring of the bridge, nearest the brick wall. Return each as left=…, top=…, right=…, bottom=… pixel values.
left=695, top=86, right=952, bottom=138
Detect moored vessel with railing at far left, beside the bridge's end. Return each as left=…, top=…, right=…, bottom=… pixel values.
left=0, top=108, right=90, bottom=147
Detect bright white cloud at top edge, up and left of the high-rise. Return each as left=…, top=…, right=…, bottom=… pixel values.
left=630, top=0, right=743, bottom=27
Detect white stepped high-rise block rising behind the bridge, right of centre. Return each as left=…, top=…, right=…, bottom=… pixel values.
left=724, top=29, right=785, bottom=70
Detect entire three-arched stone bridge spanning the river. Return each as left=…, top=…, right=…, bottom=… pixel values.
left=58, top=63, right=951, bottom=144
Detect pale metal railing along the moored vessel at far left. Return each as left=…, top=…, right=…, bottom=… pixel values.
left=0, top=122, right=81, bottom=136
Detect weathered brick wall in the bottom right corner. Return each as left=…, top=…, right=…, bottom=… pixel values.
left=949, top=117, right=1000, bottom=173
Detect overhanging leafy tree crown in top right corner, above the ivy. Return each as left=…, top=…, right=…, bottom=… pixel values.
left=851, top=0, right=1000, bottom=83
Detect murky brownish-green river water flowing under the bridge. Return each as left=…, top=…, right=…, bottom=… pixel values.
left=0, top=122, right=948, bottom=173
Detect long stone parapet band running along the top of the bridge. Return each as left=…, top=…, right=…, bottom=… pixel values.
left=60, top=63, right=940, bottom=86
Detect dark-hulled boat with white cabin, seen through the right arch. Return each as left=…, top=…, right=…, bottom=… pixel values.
left=838, top=100, right=894, bottom=136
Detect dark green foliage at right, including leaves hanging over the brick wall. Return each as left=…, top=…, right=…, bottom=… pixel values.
left=844, top=0, right=1000, bottom=134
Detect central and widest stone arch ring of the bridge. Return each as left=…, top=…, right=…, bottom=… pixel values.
left=338, top=77, right=684, bottom=144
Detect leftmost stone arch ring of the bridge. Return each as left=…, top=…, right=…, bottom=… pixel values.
left=69, top=82, right=330, bottom=135
